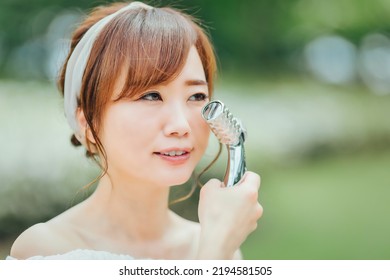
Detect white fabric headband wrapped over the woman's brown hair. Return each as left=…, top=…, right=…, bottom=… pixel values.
left=64, top=2, right=151, bottom=133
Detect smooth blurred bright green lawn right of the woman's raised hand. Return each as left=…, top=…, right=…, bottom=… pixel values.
left=242, top=149, right=390, bottom=260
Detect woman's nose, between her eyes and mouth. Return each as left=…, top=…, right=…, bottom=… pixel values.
left=164, top=103, right=191, bottom=137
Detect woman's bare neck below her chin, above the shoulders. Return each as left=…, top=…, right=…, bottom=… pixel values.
left=89, top=175, right=172, bottom=241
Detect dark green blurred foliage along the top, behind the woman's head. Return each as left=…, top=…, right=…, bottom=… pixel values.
left=0, top=0, right=390, bottom=77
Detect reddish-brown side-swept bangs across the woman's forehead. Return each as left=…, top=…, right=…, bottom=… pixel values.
left=96, top=8, right=197, bottom=100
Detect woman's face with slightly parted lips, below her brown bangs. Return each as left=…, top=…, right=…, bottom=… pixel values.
left=99, top=47, right=210, bottom=186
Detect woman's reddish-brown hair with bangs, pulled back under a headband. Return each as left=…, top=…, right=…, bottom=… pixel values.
left=58, top=3, right=216, bottom=160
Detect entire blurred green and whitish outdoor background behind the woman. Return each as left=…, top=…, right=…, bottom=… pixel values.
left=0, top=0, right=390, bottom=259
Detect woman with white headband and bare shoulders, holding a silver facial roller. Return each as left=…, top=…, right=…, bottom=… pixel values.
left=10, top=2, right=262, bottom=259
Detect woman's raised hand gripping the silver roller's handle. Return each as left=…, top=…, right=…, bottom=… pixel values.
left=198, top=172, right=263, bottom=259
